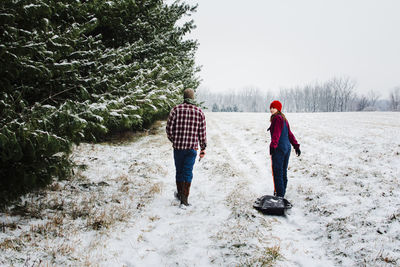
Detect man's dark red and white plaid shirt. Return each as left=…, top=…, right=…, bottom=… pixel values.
left=166, top=103, right=207, bottom=149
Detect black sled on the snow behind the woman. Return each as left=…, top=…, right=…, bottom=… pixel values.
left=253, top=195, right=292, bottom=215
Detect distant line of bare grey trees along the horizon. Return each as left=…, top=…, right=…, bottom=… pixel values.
left=197, top=77, right=400, bottom=112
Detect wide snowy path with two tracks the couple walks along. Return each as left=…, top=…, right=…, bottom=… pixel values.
left=97, top=114, right=338, bottom=266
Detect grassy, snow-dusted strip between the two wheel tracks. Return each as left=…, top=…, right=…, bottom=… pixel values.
left=203, top=118, right=279, bottom=266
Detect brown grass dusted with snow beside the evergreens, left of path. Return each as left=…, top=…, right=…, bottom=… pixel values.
left=0, top=129, right=166, bottom=266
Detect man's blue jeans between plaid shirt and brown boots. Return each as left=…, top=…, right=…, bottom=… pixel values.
left=174, top=149, right=197, bottom=183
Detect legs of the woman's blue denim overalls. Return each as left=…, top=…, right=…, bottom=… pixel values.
left=272, top=148, right=290, bottom=197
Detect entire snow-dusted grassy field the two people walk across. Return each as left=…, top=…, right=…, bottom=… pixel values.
left=0, top=113, right=400, bottom=266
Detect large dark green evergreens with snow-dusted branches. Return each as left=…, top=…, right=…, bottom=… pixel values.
left=0, top=0, right=199, bottom=203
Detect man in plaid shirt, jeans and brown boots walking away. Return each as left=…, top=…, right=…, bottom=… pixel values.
left=166, top=89, right=207, bottom=206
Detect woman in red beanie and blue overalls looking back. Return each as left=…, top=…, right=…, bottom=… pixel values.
left=268, top=100, right=301, bottom=206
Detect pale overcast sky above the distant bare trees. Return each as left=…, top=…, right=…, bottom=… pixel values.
left=186, top=0, right=400, bottom=98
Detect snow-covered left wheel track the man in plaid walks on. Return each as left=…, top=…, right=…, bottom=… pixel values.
left=101, top=119, right=242, bottom=266
